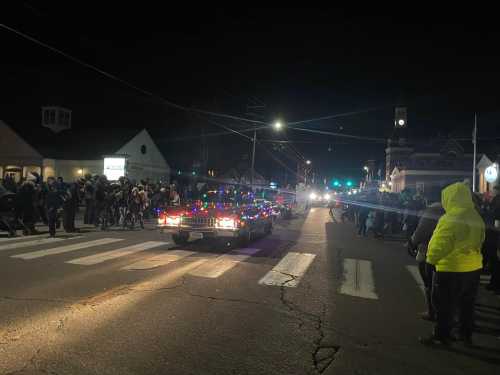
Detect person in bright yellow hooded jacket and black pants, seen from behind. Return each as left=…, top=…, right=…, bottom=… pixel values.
left=421, top=183, right=485, bottom=345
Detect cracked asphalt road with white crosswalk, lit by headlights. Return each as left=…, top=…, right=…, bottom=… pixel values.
left=0, top=208, right=500, bottom=375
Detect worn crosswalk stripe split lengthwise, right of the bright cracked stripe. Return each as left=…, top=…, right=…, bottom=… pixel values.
left=339, top=258, right=378, bottom=299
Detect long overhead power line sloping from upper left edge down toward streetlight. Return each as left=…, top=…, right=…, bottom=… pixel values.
left=0, top=23, right=265, bottom=124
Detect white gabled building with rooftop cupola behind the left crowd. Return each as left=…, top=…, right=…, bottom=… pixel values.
left=0, top=117, right=170, bottom=181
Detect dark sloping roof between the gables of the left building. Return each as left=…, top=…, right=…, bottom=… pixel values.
left=10, top=126, right=141, bottom=160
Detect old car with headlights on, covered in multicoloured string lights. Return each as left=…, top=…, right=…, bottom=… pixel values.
left=158, top=191, right=273, bottom=246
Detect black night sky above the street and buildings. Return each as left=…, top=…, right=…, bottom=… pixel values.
left=0, top=1, right=500, bottom=184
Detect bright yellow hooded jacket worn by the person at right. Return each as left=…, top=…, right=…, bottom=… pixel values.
left=426, top=183, right=485, bottom=272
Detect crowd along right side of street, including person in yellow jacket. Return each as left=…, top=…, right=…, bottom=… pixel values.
left=343, top=183, right=500, bottom=346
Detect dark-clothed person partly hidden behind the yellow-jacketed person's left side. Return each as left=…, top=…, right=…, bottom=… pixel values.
left=409, top=202, right=444, bottom=321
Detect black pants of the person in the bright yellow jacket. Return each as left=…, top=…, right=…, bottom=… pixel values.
left=432, top=270, right=480, bottom=339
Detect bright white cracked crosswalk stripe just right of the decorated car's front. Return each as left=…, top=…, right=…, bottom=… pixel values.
left=259, top=252, right=316, bottom=288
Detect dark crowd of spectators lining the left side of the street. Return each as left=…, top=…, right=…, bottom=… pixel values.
left=0, top=173, right=189, bottom=236
